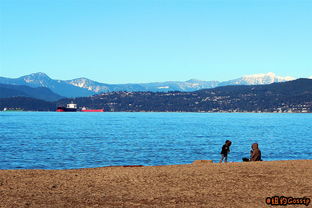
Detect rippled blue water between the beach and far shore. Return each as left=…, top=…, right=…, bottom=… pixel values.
left=0, top=112, right=312, bottom=169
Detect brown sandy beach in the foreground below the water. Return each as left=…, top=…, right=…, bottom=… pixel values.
left=0, top=160, right=312, bottom=208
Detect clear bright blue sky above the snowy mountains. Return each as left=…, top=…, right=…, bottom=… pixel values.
left=0, top=0, right=312, bottom=83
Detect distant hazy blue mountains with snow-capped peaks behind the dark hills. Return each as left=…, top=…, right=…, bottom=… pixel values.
left=0, top=72, right=304, bottom=98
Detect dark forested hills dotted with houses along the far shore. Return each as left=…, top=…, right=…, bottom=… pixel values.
left=0, top=79, right=312, bottom=113
